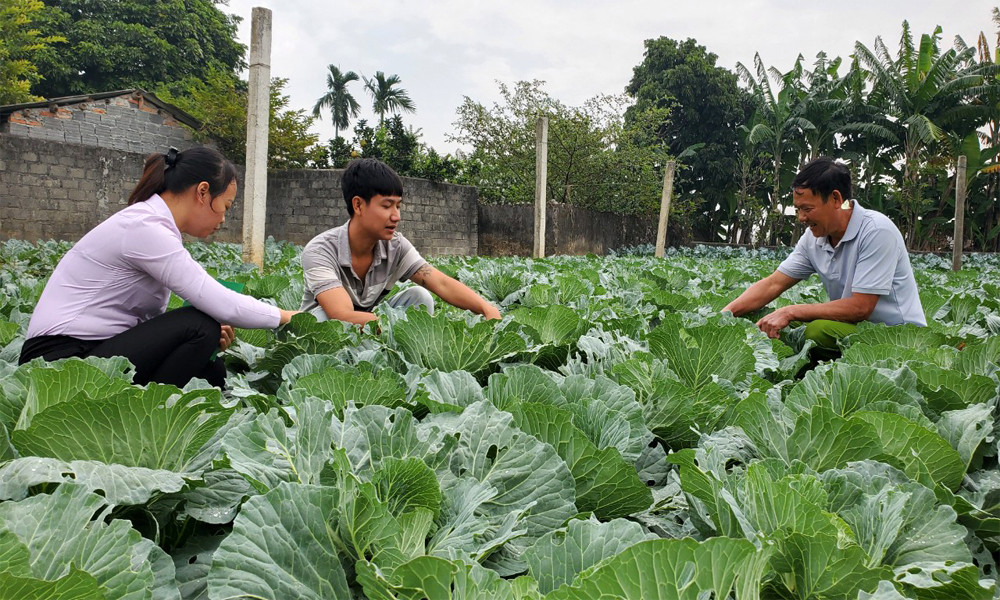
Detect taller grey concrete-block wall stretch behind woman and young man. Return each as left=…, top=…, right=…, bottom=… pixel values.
left=0, top=134, right=478, bottom=256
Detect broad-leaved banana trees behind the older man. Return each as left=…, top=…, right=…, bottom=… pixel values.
left=730, top=18, right=1000, bottom=250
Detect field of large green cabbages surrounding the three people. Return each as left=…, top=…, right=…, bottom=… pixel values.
left=0, top=240, right=1000, bottom=600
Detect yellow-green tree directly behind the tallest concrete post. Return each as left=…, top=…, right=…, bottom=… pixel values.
left=156, top=70, right=327, bottom=169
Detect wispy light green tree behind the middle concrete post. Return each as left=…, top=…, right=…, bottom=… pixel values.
left=449, top=81, right=667, bottom=214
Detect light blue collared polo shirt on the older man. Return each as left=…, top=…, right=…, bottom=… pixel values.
left=778, top=200, right=927, bottom=326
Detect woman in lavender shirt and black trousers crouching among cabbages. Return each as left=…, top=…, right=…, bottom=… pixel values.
left=20, top=147, right=294, bottom=387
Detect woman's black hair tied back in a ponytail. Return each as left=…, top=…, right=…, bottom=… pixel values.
left=128, top=146, right=236, bottom=205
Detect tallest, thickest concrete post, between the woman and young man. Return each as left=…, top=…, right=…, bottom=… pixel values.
left=243, top=6, right=271, bottom=270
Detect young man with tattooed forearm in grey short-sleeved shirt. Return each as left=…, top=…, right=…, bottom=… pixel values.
left=302, top=158, right=500, bottom=325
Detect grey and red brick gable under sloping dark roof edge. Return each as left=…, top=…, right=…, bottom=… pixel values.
left=0, top=89, right=207, bottom=154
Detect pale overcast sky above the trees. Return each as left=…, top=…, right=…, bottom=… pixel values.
left=220, top=0, right=996, bottom=152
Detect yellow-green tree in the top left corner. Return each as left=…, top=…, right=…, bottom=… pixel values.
left=0, top=0, right=66, bottom=104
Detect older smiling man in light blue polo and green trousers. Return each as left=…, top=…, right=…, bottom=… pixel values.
left=723, top=157, right=927, bottom=359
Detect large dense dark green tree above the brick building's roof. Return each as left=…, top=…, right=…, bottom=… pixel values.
left=27, top=0, right=246, bottom=98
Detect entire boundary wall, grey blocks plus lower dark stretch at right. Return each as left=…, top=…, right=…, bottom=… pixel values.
left=0, top=134, right=656, bottom=256
